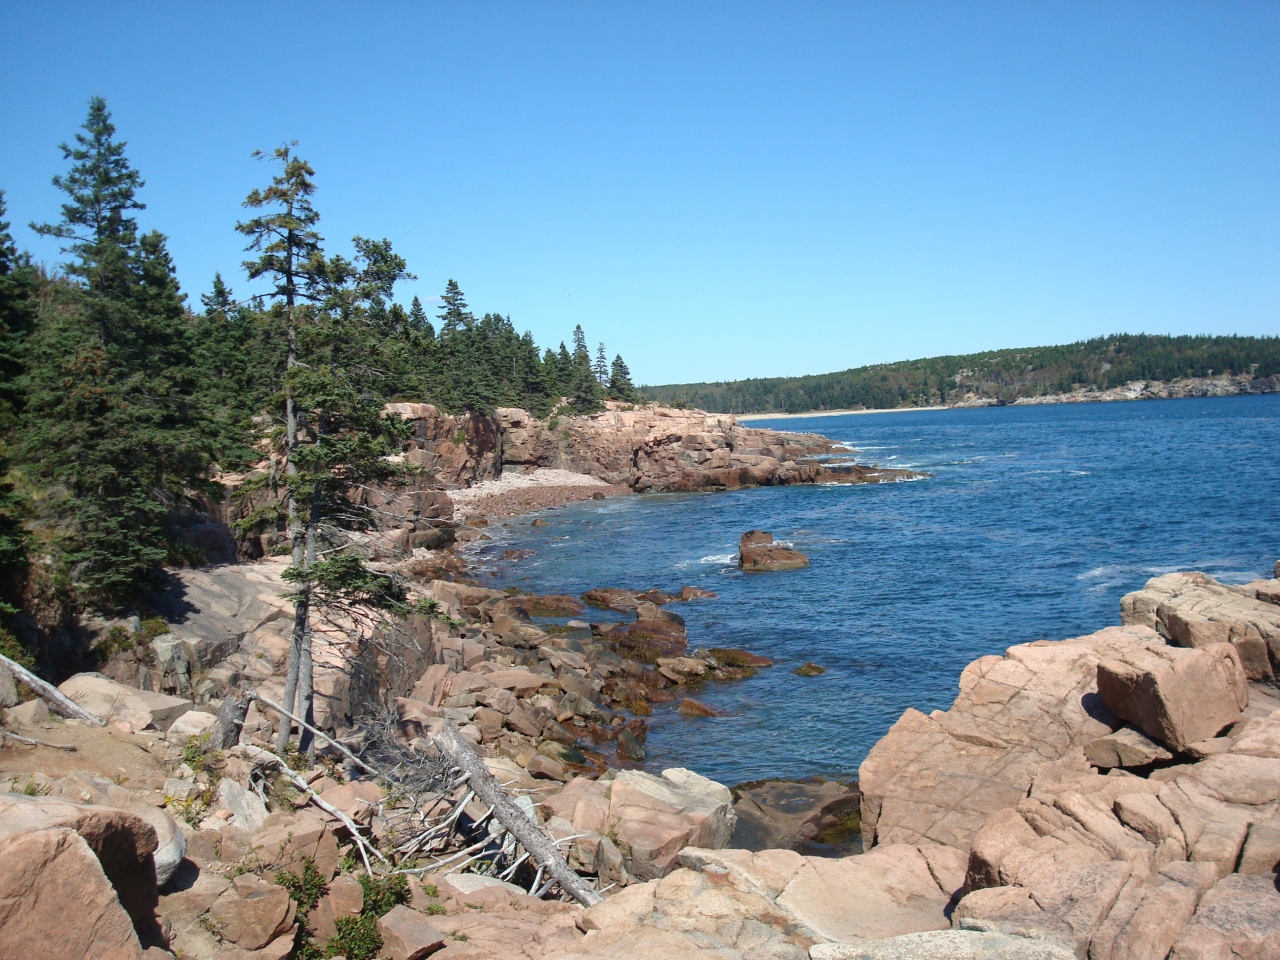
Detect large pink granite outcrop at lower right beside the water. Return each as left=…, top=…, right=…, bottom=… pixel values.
left=859, top=573, right=1280, bottom=960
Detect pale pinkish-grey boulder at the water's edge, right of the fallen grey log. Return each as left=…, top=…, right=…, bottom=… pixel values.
left=603, top=768, right=737, bottom=879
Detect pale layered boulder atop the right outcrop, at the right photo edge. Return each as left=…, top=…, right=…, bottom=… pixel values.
left=1120, top=573, right=1280, bottom=680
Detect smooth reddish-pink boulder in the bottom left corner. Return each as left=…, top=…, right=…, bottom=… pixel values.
left=0, top=827, right=142, bottom=960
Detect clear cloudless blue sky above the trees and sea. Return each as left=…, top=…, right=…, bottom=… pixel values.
left=0, top=0, right=1280, bottom=383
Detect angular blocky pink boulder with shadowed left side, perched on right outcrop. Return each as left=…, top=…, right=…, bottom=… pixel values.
left=1098, top=644, right=1249, bottom=751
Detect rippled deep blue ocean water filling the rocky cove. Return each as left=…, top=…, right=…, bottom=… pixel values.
left=477, top=396, right=1280, bottom=785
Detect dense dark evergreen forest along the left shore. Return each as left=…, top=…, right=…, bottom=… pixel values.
left=0, top=99, right=635, bottom=632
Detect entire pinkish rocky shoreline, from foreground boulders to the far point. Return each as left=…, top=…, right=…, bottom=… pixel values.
left=0, top=408, right=1280, bottom=960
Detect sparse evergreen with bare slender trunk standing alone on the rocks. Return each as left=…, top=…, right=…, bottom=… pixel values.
left=237, top=158, right=410, bottom=750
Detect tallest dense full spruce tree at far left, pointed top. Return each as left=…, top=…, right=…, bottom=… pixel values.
left=18, top=97, right=207, bottom=607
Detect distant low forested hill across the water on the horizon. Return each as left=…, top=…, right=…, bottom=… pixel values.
left=641, top=334, right=1280, bottom=413
